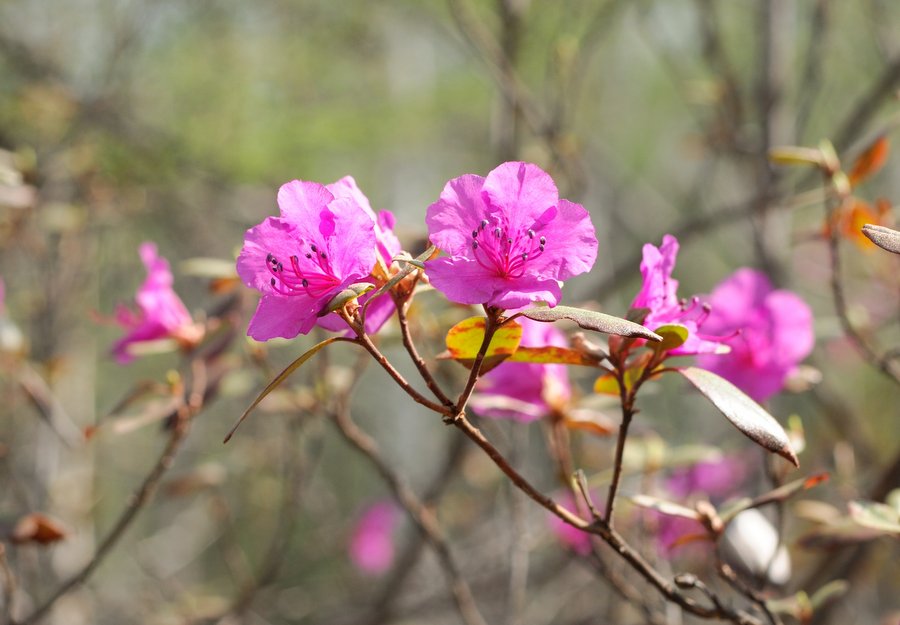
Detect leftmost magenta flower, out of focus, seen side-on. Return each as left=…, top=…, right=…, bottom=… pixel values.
left=112, top=243, right=203, bottom=363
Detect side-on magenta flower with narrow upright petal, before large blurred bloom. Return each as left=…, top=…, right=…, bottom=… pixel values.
left=631, top=234, right=728, bottom=355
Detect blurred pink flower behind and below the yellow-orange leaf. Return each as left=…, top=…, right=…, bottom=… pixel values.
left=469, top=317, right=572, bottom=423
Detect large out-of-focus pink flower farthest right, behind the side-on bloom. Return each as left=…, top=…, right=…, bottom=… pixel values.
left=697, top=268, right=815, bottom=402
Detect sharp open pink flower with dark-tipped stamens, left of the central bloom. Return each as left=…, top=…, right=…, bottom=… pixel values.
left=237, top=180, right=376, bottom=341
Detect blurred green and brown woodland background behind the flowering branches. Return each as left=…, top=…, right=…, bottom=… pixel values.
left=0, top=0, right=900, bottom=625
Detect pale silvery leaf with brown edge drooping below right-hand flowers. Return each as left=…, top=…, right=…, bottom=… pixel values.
left=676, top=367, right=800, bottom=467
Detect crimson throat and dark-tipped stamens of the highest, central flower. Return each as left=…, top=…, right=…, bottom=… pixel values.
left=472, top=219, right=547, bottom=278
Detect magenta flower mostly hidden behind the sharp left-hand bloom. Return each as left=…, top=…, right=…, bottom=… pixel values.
left=318, top=176, right=403, bottom=334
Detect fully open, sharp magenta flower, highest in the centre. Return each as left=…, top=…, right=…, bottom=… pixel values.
left=425, top=162, right=597, bottom=309
